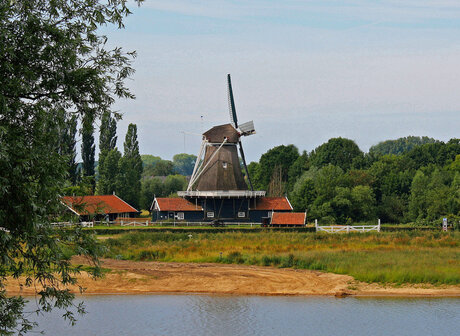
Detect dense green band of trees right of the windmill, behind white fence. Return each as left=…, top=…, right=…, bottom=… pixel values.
left=248, top=137, right=460, bottom=224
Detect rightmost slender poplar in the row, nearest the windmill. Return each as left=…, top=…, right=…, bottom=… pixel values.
left=117, top=124, right=142, bottom=208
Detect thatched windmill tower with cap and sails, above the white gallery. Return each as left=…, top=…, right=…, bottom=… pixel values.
left=187, top=74, right=255, bottom=192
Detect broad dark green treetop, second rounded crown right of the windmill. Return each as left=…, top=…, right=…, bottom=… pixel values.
left=310, top=138, right=364, bottom=171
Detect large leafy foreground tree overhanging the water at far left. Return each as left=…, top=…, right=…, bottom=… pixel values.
left=0, top=0, right=134, bottom=334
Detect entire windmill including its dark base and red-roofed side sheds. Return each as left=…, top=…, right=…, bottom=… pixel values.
left=151, top=75, right=305, bottom=226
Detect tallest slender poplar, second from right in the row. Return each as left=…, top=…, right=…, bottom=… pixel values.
left=97, top=112, right=118, bottom=195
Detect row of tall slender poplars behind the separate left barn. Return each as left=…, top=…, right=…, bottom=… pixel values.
left=59, top=111, right=143, bottom=208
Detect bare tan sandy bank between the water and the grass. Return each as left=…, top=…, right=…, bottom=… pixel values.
left=7, top=258, right=460, bottom=296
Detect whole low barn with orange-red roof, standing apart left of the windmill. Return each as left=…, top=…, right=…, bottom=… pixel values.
left=61, top=195, right=139, bottom=221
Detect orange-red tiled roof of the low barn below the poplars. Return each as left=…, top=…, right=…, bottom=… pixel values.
left=62, top=195, right=138, bottom=215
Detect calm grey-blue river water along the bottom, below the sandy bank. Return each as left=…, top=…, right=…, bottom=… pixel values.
left=29, top=295, right=460, bottom=336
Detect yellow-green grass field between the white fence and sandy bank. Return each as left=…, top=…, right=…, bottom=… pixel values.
left=104, top=230, right=460, bottom=284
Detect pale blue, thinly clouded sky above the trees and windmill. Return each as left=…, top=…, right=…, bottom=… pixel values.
left=101, top=0, right=460, bottom=161
